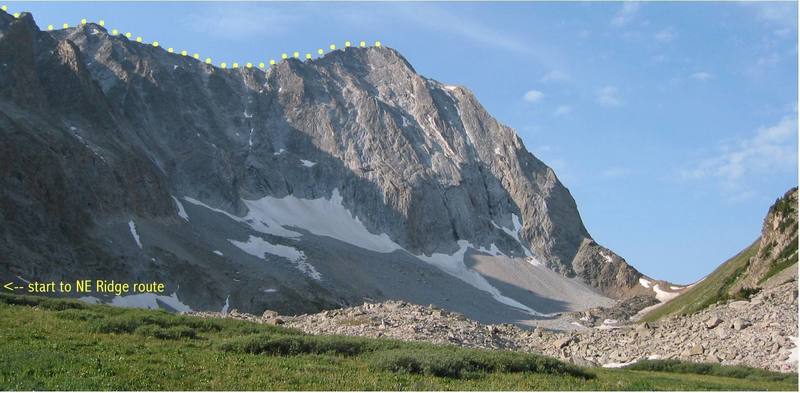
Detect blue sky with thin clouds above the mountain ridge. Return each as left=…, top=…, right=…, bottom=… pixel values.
left=4, top=2, right=798, bottom=283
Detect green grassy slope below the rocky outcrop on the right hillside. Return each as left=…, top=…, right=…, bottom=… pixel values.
left=641, top=241, right=758, bottom=322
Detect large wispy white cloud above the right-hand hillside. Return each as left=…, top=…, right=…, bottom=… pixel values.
left=680, top=113, right=797, bottom=188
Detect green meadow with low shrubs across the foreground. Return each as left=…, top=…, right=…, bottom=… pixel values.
left=0, top=295, right=797, bottom=391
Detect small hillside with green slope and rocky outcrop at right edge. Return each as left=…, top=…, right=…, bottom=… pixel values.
left=642, top=187, right=798, bottom=321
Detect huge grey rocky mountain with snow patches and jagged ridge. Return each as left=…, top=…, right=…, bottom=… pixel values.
left=0, top=13, right=655, bottom=322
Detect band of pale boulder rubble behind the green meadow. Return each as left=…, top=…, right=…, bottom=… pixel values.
left=189, top=280, right=798, bottom=372
